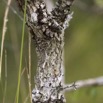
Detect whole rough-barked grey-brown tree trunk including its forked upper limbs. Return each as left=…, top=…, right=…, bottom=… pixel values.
left=17, top=0, right=73, bottom=103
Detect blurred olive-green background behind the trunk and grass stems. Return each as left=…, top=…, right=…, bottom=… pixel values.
left=0, top=0, right=103, bottom=103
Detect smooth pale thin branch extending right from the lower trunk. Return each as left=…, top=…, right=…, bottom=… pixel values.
left=64, top=76, right=103, bottom=91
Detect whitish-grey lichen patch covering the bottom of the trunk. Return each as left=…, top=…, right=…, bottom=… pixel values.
left=32, top=72, right=65, bottom=103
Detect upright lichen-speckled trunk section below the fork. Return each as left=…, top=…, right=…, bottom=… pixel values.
left=33, top=34, right=64, bottom=103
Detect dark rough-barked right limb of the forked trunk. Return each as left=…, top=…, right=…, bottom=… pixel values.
left=52, top=0, right=74, bottom=27
